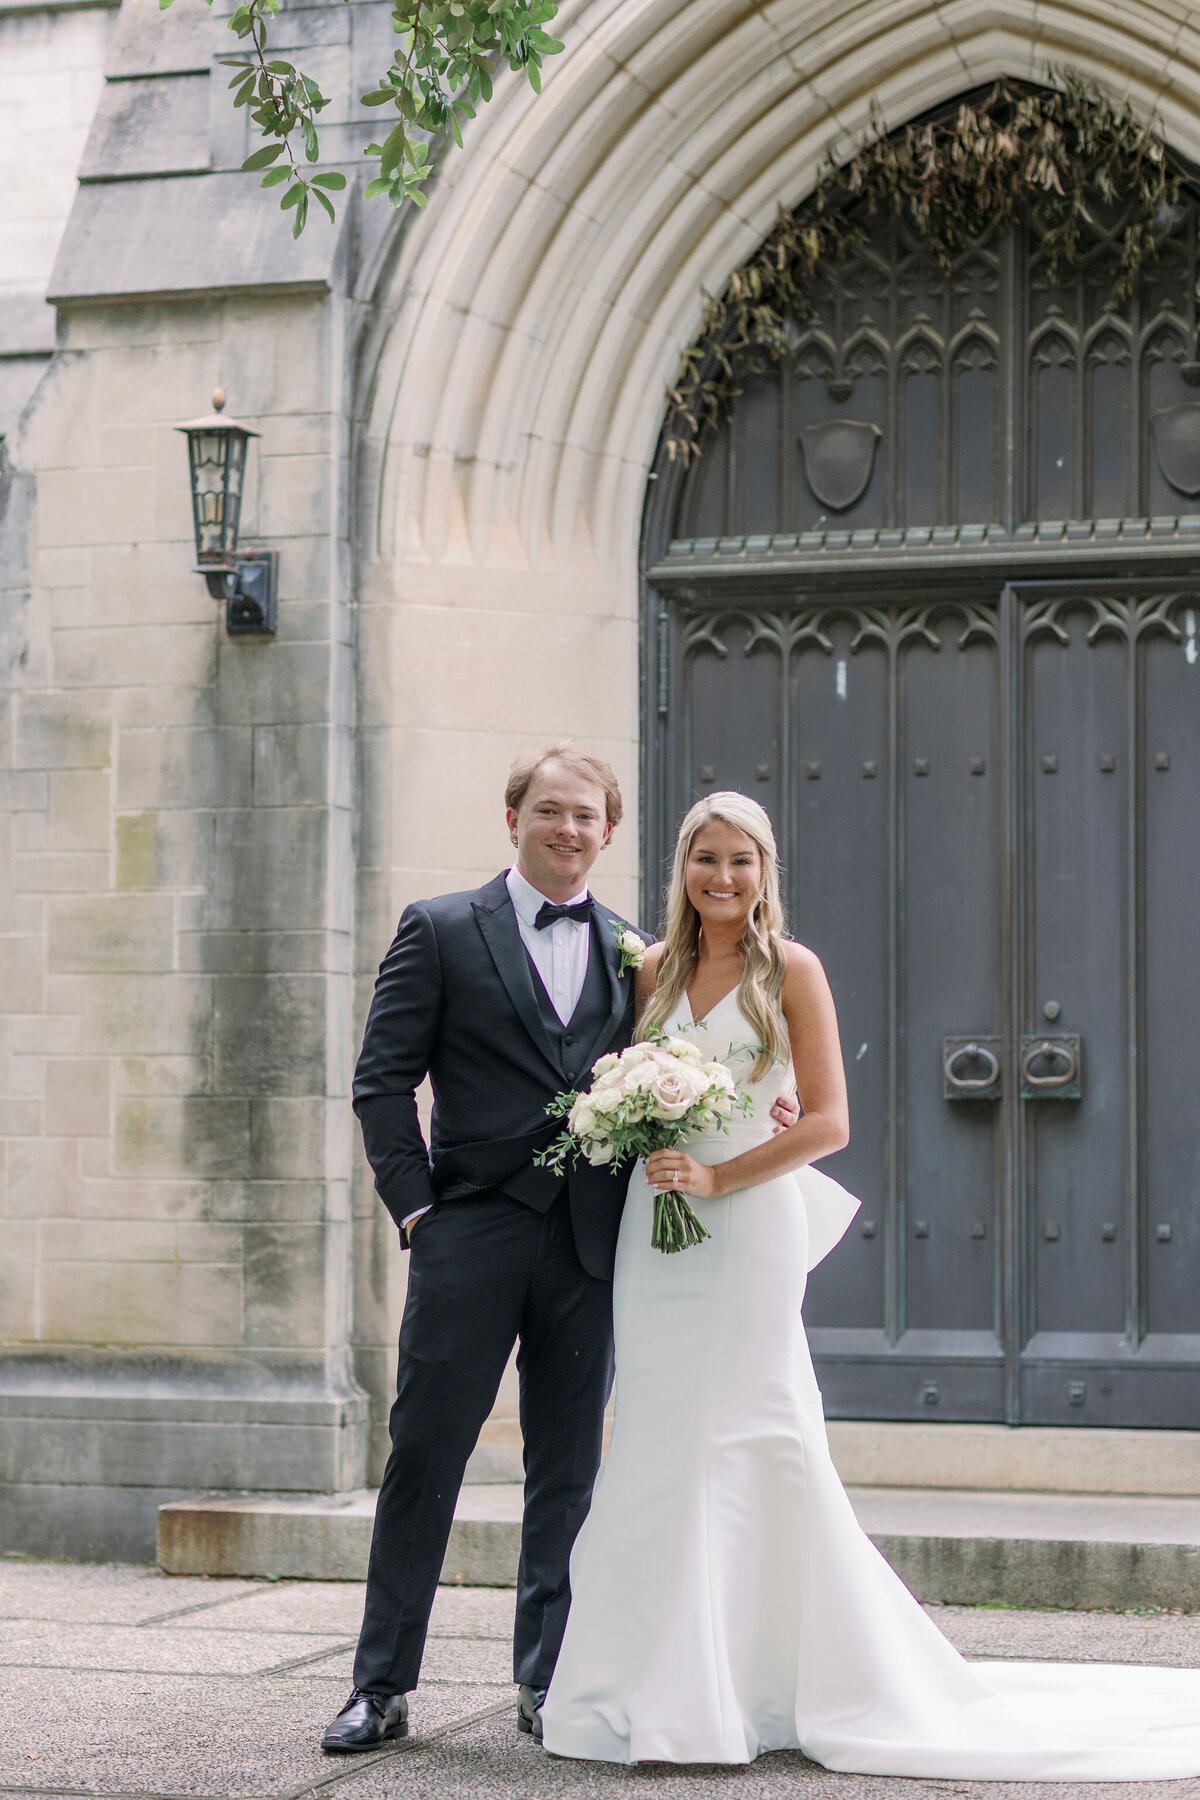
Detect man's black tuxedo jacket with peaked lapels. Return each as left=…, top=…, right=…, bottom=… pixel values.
left=354, top=875, right=649, bottom=1280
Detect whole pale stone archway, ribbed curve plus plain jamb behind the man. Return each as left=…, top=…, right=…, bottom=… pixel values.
left=347, top=0, right=1200, bottom=1461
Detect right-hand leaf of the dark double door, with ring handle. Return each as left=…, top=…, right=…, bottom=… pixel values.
left=1007, top=581, right=1200, bottom=1426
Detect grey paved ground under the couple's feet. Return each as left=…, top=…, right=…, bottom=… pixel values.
left=0, top=1559, right=1200, bottom=1800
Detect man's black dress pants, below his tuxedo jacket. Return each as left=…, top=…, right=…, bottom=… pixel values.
left=354, top=1188, right=612, bottom=1694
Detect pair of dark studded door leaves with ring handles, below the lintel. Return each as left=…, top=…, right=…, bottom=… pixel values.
left=667, top=581, right=1200, bottom=1424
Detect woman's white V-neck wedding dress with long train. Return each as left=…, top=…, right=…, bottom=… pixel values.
left=543, top=994, right=1200, bottom=1780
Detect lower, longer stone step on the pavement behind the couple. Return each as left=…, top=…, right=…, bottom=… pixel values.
left=158, top=1483, right=1200, bottom=1613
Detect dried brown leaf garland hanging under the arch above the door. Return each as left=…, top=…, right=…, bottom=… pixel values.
left=664, top=70, right=1180, bottom=464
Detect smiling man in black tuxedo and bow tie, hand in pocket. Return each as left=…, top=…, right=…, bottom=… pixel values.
left=322, top=743, right=647, bottom=1751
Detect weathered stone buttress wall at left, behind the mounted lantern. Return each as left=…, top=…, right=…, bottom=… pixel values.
left=0, top=4, right=367, bottom=1559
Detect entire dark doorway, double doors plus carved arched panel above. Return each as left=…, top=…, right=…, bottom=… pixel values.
left=644, top=123, right=1200, bottom=1427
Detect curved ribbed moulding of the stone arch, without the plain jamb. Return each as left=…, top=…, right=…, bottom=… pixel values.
left=362, top=0, right=1200, bottom=581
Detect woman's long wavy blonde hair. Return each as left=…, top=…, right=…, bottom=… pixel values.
left=637, top=790, right=790, bottom=1082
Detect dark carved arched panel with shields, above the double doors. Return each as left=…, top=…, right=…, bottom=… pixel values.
left=671, top=205, right=1200, bottom=538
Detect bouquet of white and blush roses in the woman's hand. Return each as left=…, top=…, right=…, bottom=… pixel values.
left=534, top=1031, right=754, bottom=1255
